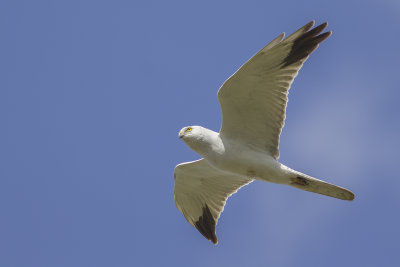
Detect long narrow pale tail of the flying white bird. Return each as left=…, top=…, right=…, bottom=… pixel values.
left=289, top=171, right=354, bottom=201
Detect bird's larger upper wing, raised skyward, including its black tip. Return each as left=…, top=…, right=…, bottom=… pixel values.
left=218, top=21, right=331, bottom=159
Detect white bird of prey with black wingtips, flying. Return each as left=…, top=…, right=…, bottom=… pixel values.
left=174, top=20, right=354, bottom=245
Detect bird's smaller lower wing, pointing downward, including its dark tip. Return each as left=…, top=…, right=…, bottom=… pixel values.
left=174, top=159, right=253, bottom=244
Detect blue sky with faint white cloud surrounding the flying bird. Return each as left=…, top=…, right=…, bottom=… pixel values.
left=0, top=0, right=400, bottom=267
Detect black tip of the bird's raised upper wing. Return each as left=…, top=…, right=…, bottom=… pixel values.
left=282, top=21, right=332, bottom=68
